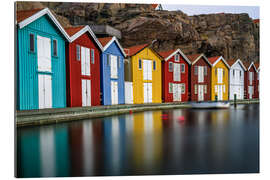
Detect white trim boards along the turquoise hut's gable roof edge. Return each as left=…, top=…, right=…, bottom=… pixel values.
left=18, top=8, right=70, bottom=42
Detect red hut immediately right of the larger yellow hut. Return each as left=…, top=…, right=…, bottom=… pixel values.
left=159, top=49, right=190, bottom=102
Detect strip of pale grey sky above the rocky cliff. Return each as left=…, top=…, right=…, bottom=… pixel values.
left=162, top=4, right=260, bottom=19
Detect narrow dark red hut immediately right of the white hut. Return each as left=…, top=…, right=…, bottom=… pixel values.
left=244, top=62, right=257, bottom=99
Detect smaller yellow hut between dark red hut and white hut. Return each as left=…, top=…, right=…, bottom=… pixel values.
left=208, top=56, right=230, bottom=101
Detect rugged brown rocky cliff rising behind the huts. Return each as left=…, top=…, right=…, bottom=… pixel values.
left=16, top=2, right=259, bottom=61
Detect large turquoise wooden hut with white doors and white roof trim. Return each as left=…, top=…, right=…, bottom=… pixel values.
left=16, top=8, right=69, bottom=110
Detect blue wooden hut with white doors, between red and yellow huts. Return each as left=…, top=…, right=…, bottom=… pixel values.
left=98, top=36, right=126, bottom=105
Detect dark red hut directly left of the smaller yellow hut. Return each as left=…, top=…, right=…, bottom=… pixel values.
left=187, top=54, right=211, bottom=101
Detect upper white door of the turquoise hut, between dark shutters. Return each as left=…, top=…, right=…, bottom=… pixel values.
left=37, top=36, right=52, bottom=72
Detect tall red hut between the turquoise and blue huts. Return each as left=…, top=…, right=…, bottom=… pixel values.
left=65, top=26, right=102, bottom=107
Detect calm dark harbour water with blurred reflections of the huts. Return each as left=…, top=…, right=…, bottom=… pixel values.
left=17, top=104, right=259, bottom=177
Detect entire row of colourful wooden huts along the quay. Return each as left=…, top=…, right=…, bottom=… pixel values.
left=16, top=8, right=260, bottom=110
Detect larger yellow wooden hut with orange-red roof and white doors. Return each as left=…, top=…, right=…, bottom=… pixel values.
left=125, top=44, right=162, bottom=104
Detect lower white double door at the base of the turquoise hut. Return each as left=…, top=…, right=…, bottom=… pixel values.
left=38, top=74, right=52, bottom=109
